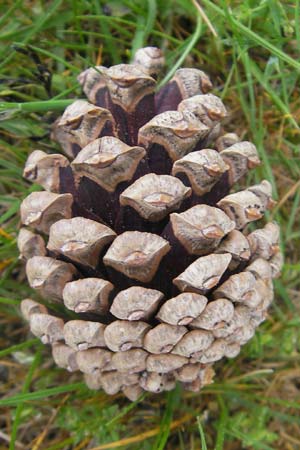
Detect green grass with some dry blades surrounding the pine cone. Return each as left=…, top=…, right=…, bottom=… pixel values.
left=0, top=0, right=300, bottom=450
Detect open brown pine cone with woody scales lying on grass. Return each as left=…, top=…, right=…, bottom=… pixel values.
left=18, top=47, right=282, bottom=400
